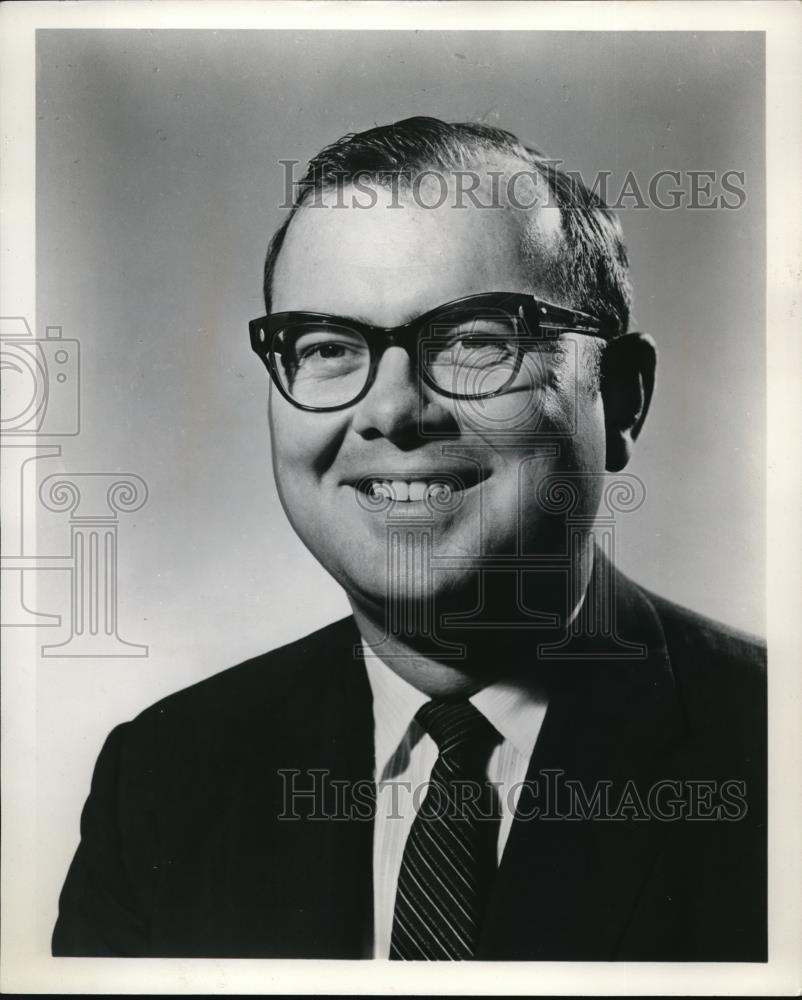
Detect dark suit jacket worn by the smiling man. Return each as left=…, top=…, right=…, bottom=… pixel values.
left=53, top=574, right=767, bottom=961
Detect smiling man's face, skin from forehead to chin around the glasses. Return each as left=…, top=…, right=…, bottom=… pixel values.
left=270, top=179, right=604, bottom=609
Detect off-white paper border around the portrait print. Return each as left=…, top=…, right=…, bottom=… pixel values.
left=0, top=0, right=802, bottom=995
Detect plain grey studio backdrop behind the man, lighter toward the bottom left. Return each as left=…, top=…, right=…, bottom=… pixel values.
left=36, top=30, right=765, bottom=948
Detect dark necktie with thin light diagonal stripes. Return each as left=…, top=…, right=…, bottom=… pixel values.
left=390, top=701, right=501, bottom=959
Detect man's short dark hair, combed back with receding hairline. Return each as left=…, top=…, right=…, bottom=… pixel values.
left=264, top=117, right=632, bottom=333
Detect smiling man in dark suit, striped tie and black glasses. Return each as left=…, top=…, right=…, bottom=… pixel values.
left=53, top=118, right=766, bottom=961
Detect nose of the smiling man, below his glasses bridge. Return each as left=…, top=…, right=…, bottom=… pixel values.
left=352, top=346, right=449, bottom=446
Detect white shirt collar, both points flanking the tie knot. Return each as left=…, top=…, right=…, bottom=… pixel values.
left=362, top=639, right=548, bottom=778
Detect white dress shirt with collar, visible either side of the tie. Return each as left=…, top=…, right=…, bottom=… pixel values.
left=363, top=641, right=547, bottom=958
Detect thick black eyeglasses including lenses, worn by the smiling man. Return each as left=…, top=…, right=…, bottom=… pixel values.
left=248, top=292, right=619, bottom=413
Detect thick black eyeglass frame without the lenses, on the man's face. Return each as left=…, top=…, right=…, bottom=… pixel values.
left=248, top=292, right=621, bottom=413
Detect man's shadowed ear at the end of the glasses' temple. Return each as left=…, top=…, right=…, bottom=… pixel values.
left=601, top=333, right=657, bottom=472
